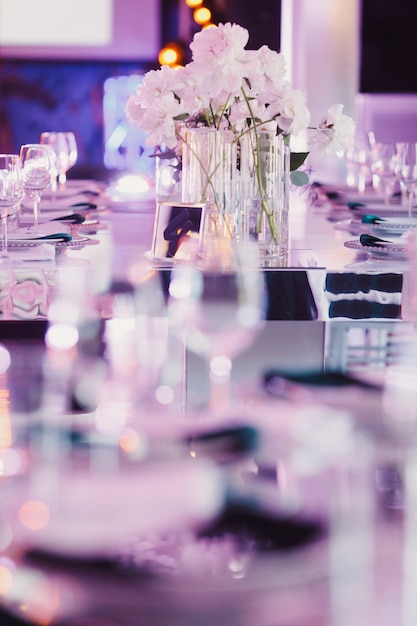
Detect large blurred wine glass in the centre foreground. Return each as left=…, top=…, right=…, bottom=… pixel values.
left=168, top=240, right=266, bottom=413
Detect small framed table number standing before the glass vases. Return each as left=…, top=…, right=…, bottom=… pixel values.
left=151, top=202, right=205, bottom=260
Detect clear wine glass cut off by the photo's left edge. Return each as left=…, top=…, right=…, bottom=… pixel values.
left=0, top=154, right=24, bottom=257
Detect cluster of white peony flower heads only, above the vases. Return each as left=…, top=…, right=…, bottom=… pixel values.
left=126, top=23, right=355, bottom=177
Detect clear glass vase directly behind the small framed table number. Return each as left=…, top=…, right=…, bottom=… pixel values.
left=181, top=126, right=238, bottom=238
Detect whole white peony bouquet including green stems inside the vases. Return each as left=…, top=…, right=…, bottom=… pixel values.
left=126, top=23, right=355, bottom=255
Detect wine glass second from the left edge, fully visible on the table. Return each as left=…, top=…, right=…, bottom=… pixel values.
left=20, top=143, right=55, bottom=233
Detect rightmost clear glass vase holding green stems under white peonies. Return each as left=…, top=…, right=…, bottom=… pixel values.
left=240, top=128, right=290, bottom=267
